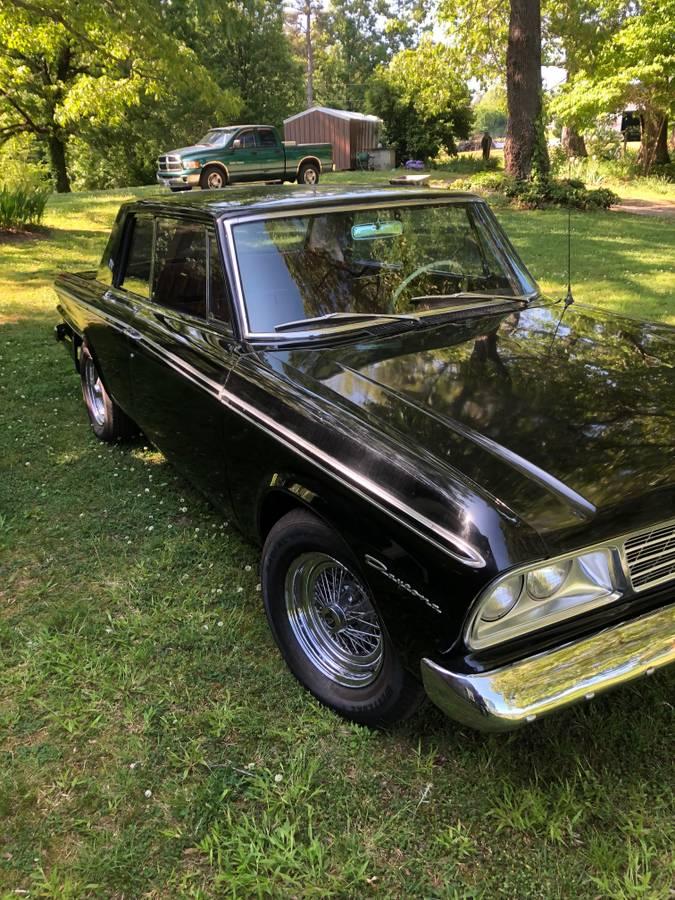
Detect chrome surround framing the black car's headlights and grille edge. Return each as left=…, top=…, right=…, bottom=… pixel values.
left=463, top=519, right=675, bottom=650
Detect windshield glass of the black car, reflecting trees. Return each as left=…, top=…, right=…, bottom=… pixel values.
left=232, top=202, right=537, bottom=333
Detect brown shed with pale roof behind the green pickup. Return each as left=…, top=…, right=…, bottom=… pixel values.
left=284, top=106, right=382, bottom=169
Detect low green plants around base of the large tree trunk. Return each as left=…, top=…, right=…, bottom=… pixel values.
left=452, top=172, right=619, bottom=209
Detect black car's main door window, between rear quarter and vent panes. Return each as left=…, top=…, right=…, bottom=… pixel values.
left=152, top=219, right=206, bottom=318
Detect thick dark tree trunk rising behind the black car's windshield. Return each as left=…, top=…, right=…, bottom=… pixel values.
left=504, top=0, right=549, bottom=181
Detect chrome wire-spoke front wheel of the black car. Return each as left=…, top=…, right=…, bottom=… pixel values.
left=285, top=553, right=383, bottom=688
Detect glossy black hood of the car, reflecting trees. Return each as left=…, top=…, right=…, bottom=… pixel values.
left=270, top=304, right=675, bottom=552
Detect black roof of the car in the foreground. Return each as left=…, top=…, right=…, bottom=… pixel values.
left=128, top=185, right=482, bottom=219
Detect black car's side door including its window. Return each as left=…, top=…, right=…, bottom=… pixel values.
left=131, top=216, right=236, bottom=509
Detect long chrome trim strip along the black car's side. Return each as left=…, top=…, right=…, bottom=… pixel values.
left=63, top=297, right=486, bottom=569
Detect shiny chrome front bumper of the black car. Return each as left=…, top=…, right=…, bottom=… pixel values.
left=422, top=605, right=675, bottom=731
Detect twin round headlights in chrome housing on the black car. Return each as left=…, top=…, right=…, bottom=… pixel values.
left=466, top=547, right=626, bottom=650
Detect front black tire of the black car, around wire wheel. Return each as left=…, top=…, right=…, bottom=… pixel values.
left=261, top=510, right=424, bottom=728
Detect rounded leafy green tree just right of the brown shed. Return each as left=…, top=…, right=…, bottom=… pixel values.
left=366, top=38, right=471, bottom=159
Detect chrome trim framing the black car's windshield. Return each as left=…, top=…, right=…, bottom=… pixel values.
left=218, top=196, right=539, bottom=343
